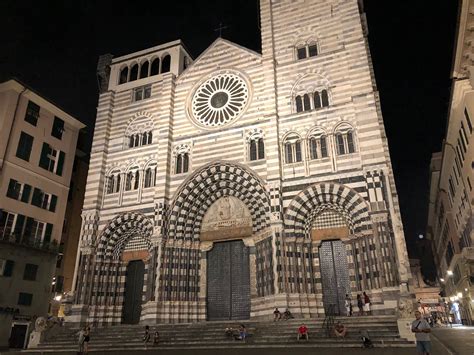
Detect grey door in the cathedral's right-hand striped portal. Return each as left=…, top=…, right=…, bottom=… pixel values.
left=319, top=240, right=350, bottom=316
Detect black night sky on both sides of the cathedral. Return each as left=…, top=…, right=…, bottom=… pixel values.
left=0, top=0, right=457, bottom=262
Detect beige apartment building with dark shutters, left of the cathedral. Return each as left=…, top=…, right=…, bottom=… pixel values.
left=0, top=80, right=85, bottom=348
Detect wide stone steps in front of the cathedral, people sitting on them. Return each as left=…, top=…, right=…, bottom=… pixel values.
left=27, top=316, right=413, bottom=352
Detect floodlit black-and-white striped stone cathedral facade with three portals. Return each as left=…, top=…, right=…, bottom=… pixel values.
left=69, top=0, right=410, bottom=325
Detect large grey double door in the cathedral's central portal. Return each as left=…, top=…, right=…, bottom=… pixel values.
left=207, top=240, right=250, bottom=320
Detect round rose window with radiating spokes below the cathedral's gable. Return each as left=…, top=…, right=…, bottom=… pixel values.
left=191, top=72, right=249, bottom=127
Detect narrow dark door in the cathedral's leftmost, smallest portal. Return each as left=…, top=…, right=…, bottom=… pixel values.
left=122, top=260, right=145, bottom=324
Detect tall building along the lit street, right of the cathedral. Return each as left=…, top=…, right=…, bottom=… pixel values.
left=427, top=0, right=474, bottom=324
